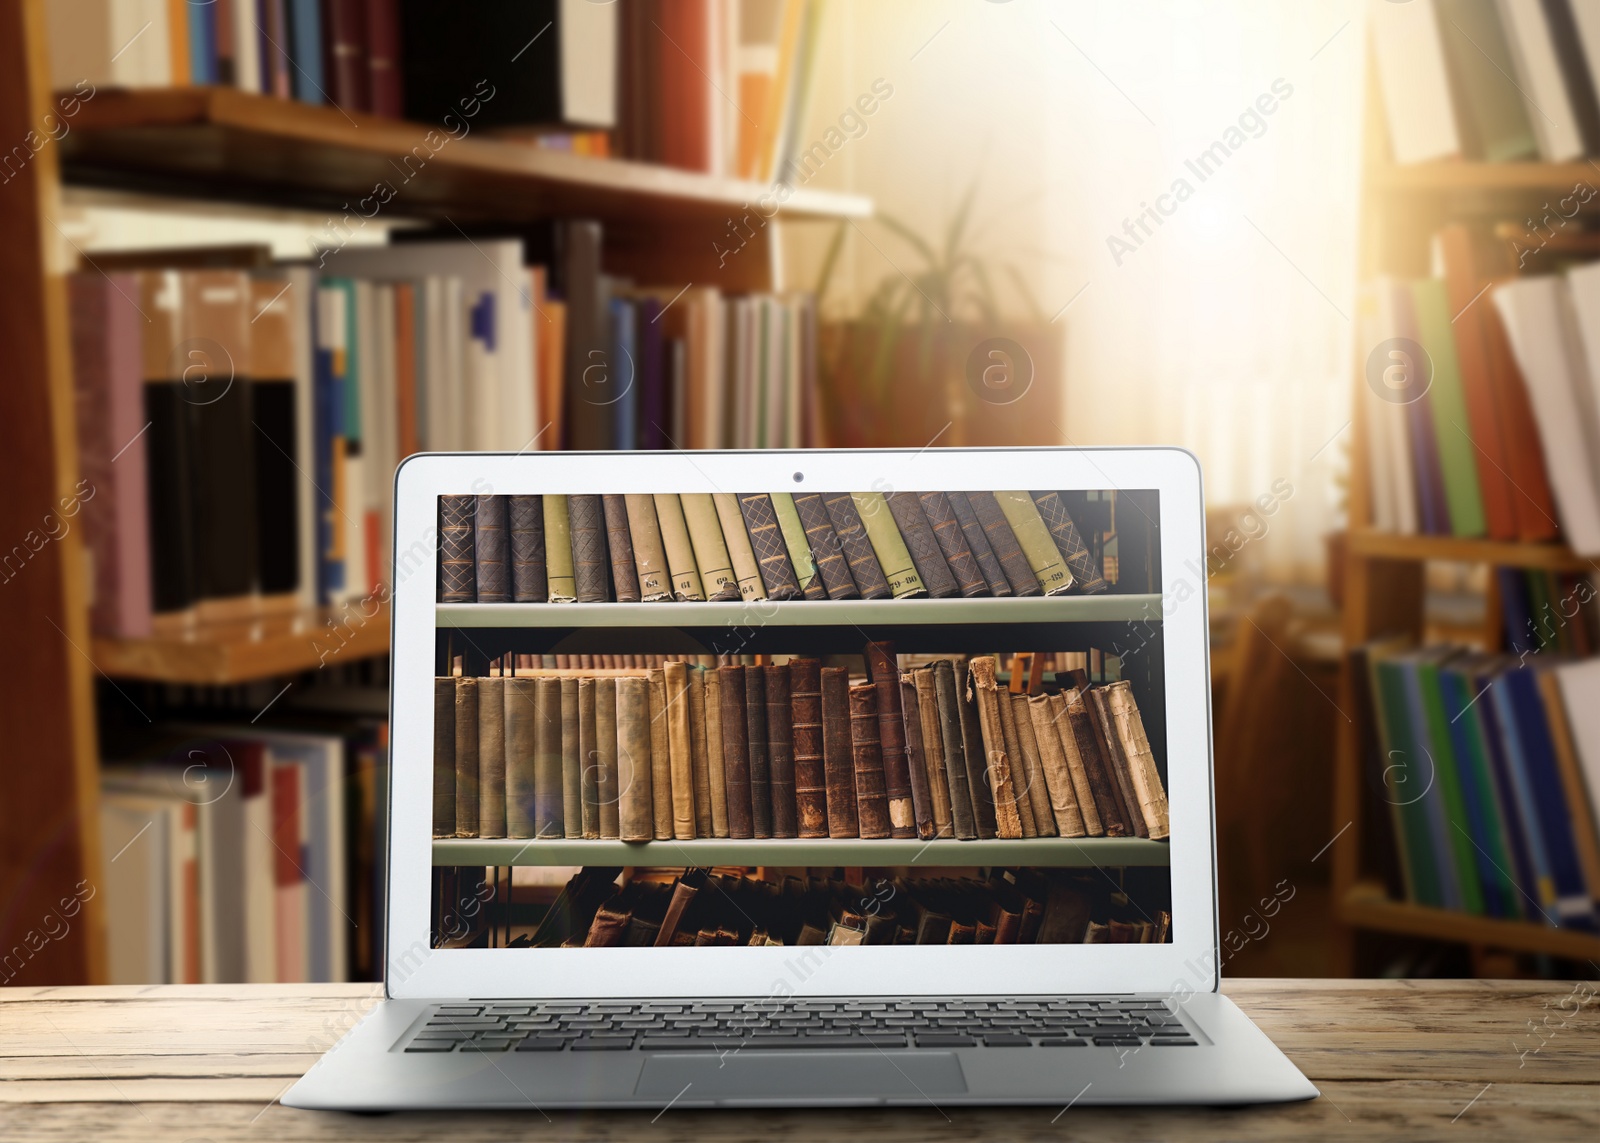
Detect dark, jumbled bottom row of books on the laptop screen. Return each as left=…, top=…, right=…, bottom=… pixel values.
left=434, top=868, right=1173, bottom=948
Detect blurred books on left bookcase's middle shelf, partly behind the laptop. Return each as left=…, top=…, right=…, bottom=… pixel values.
left=60, top=223, right=814, bottom=639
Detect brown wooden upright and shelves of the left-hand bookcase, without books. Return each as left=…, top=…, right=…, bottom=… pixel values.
left=0, top=0, right=872, bottom=985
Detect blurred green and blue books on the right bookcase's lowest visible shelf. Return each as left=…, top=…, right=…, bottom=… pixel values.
left=1355, top=642, right=1600, bottom=932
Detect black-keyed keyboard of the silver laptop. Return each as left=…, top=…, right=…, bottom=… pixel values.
left=403, top=997, right=1197, bottom=1052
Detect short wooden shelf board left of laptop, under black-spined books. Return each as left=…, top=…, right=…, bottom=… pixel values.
left=91, top=605, right=389, bottom=685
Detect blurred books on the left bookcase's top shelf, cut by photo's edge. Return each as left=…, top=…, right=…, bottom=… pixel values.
left=45, top=0, right=821, bottom=181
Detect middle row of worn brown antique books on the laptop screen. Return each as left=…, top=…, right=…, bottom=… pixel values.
left=434, top=642, right=1170, bottom=842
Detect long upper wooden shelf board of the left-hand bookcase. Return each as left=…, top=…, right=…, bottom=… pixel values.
left=58, top=86, right=872, bottom=227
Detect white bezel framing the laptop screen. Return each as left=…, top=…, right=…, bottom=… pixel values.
left=386, top=448, right=1218, bottom=997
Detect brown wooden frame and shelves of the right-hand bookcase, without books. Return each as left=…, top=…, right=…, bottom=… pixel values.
left=1333, top=51, right=1600, bottom=975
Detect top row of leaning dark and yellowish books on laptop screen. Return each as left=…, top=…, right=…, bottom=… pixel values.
left=438, top=491, right=1106, bottom=604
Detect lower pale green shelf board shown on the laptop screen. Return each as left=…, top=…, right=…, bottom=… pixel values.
left=434, top=837, right=1171, bottom=868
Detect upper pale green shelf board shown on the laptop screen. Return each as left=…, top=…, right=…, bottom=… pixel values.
left=434, top=596, right=1162, bottom=628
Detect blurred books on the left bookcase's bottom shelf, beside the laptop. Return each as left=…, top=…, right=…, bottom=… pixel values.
left=99, top=724, right=387, bottom=985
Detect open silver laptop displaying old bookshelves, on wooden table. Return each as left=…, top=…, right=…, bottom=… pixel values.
left=283, top=448, right=1317, bottom=1111
